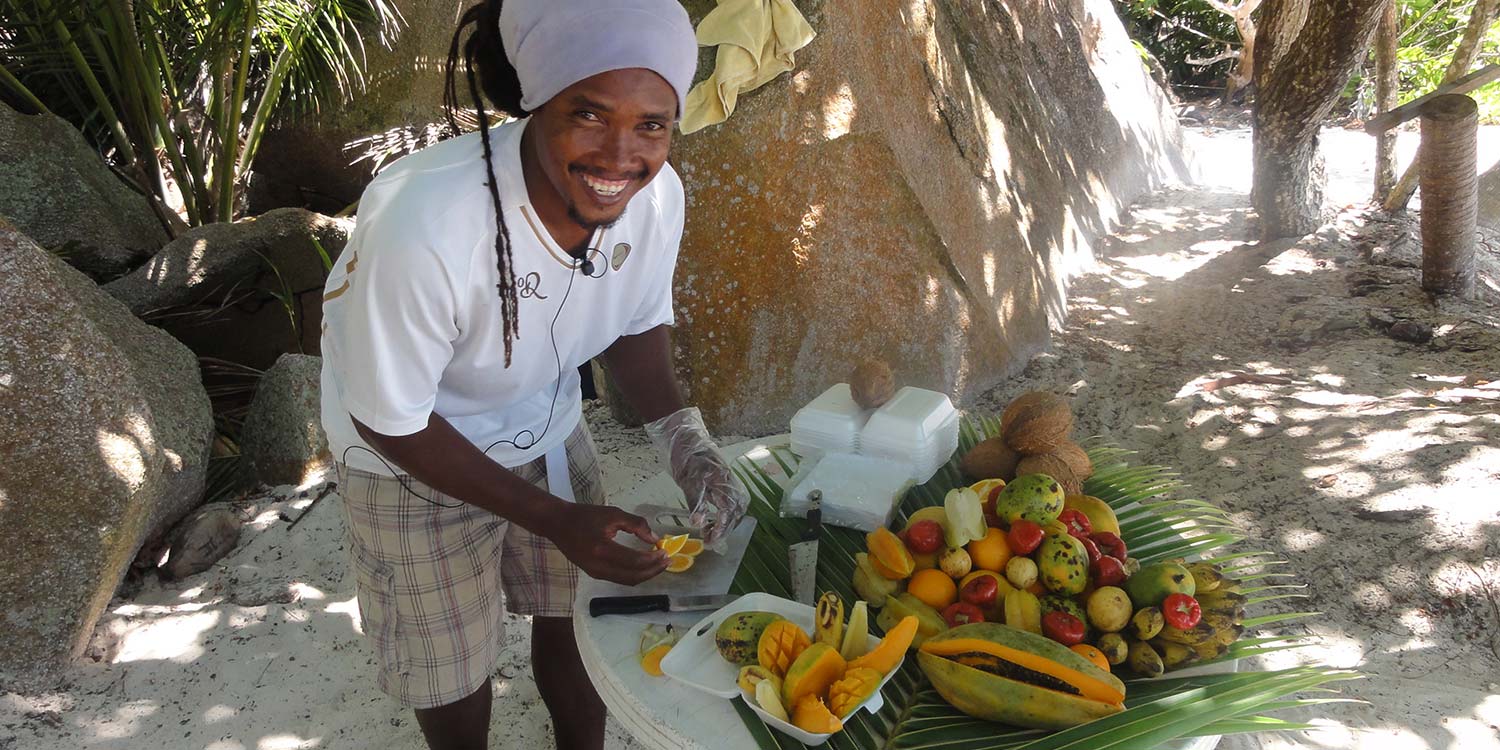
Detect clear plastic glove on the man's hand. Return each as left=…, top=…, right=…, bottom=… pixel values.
left=647, top=407, right=750, bottom=549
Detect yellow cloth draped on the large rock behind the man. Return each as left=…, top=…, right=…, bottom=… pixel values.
left=680, top=0, right=815, bottom=134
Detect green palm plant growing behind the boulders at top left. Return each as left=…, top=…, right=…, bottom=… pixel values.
left=0, top=0, right=401, bottom=225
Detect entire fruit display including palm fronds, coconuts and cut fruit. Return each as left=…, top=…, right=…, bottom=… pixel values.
left=642, top=393, right=1338, bottom=750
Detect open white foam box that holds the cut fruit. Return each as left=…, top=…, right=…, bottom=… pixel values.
left=662, top=593, right=905, bottom=746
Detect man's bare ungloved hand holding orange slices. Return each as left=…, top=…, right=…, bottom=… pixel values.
left=546, top=503, right=672, bottom=587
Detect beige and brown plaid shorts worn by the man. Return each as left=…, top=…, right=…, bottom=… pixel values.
left=338, top=420, right=605, bottom=708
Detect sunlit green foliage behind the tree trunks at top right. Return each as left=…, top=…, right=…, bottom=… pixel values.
left=1115, top=0, right=1500, bottom=122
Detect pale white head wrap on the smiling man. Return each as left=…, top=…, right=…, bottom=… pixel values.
left=500, top=0, right=698, bottom=116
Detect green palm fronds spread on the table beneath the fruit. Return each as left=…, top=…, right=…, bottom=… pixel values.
left=731, top=419, right=1359, bottom=750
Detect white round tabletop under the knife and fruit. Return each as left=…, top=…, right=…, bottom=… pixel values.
left=573, top=435, right=1220, bottom=750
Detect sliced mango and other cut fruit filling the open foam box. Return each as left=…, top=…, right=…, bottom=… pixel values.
left=714, top=591, right=918, bottom=735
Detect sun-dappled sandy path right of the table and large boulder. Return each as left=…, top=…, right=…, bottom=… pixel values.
left=977, top=184, right=1500, bottom=749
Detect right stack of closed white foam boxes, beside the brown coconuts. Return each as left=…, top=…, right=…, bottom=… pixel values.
left=860, top=386, right=959, bottom=485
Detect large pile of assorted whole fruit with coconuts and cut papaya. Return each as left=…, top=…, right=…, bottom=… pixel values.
left=852, top=393, right=1245, bottom=729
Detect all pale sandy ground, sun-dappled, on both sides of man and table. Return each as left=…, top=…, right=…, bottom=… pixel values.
left=0, top=129, right=1500, bottom=750
